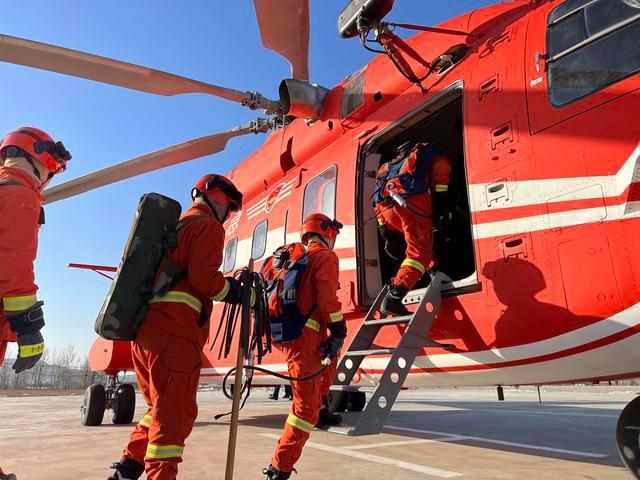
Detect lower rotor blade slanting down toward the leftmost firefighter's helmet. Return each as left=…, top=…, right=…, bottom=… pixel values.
left=44, top=120, right=271, bottom=204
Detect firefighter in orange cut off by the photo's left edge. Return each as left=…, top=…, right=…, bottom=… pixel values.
left=0, top=127, right=71, bottom=480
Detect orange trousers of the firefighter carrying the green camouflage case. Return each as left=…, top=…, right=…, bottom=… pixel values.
left=124, top=311, right=201, bottom=480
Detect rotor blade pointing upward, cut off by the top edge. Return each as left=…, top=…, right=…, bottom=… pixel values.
left=253, top=0, right=309, bottom=81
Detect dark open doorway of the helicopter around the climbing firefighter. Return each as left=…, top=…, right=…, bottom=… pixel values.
left=356, top=82, right=481, bottom=305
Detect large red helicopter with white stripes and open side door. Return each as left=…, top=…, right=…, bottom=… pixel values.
left=0, top=0, right=640, bottom=472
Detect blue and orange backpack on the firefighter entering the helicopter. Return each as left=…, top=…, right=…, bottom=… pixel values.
left=371, top=143, right=437, bottom=207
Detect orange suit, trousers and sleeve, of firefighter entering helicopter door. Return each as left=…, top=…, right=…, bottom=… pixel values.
left=375, top=155, right=452, bottom=290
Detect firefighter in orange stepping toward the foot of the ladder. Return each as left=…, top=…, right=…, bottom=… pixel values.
left=263, top=213, right=347, bottom=480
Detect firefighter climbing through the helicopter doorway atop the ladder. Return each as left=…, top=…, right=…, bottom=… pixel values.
left=373, top=143, right=451, bottom=315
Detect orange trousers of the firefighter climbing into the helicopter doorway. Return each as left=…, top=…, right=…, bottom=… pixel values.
left=377, top=194, right=434, bottom=290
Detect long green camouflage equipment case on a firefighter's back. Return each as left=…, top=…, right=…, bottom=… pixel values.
left=94, top=193, right=182, bottom=341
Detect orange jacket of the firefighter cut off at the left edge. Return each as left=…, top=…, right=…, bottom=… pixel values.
left=0, top=167, right=43, bottom=364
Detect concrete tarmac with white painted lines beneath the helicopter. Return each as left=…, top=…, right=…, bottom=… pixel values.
left=0, top=387, right=640, bottom=480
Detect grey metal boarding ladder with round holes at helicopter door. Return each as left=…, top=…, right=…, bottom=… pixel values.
left=328, top=272, right=452, bottom=436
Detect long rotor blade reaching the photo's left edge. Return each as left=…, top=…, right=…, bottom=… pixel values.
left=0, top=35, right=277, bottom=114
